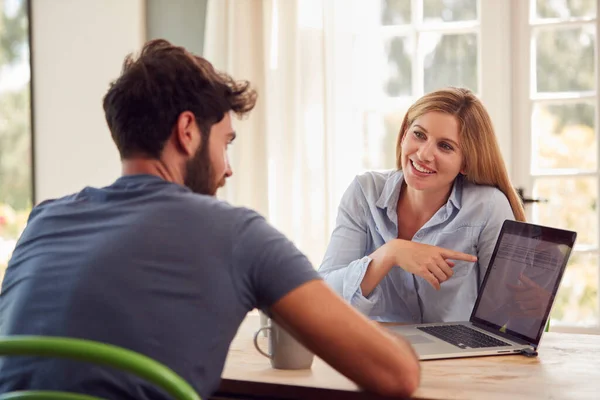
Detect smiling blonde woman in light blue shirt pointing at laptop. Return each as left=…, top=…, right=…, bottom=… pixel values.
left=319, top=88, right=525, bottom=322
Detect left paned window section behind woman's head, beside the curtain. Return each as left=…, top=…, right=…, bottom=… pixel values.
left=355, top=0, right=480, bottom=170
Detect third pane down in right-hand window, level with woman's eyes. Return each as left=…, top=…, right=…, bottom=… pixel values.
left=532, top=103, right=597, bottom=171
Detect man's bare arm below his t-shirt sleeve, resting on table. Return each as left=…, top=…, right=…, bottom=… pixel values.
left=271, top=280, right=420, bottom=397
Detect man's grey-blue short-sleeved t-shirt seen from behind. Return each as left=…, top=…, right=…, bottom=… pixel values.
left=0, top=175, right=319, bottom=399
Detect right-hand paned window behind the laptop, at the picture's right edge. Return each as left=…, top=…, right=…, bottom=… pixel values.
left=515, top=0, right=600, bottom=329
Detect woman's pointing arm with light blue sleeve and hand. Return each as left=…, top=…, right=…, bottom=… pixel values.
left=319, top=179, right=477, bottom=314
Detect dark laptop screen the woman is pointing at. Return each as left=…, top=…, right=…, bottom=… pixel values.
left=471, top=220, right=577, bottom=345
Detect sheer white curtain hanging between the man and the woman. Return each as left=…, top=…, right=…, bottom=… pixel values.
left=204, top=0, right=376, bottom=267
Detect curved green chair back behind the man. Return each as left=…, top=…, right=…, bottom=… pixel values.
left=0, top=336, right=200, bottom=400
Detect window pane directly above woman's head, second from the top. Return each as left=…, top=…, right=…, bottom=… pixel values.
left=419, top=32, right=479, bottom=93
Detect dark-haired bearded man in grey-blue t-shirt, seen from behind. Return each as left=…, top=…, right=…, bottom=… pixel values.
left=0, top=40, right=419, bottom=399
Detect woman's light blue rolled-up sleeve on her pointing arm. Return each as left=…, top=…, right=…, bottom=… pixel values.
left=319, top=179, right=381, bottom=315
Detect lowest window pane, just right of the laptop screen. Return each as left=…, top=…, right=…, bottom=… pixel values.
left=550, top=253, right=599, bottom=329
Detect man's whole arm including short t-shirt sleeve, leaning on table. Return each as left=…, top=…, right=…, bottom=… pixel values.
left=228, top=209, right=419, bottom=396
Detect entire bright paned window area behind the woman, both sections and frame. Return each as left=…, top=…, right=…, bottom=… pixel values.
left=353, top=0, right=600, bottom=330
